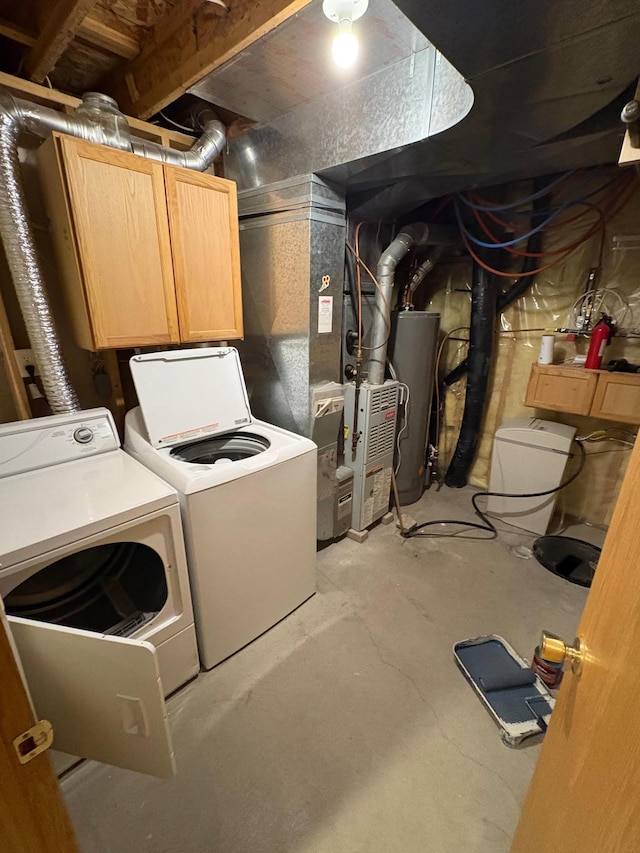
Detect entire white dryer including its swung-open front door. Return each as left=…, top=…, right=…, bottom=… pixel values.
left=0, top=409, right=199, bottom=775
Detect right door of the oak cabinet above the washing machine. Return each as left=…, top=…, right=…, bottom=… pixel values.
left=165, top=166, right=243, bottom=341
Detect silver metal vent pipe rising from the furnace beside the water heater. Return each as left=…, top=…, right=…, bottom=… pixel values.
left=368, top=222, right=459, bottom=385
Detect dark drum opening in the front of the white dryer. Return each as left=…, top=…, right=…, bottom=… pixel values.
left=4, top=542, right=168, bottom=637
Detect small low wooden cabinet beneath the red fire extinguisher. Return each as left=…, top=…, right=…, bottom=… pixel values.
left=524, top=364, right=640, bottom=424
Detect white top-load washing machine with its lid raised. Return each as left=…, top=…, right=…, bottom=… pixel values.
left=125, top=347, right=317, bottom=669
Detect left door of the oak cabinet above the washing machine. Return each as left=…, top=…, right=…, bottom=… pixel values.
left=57, top=136, right=179, bottom=349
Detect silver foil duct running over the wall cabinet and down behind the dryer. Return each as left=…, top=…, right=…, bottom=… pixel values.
left=0, top=92, right=225, bottom=413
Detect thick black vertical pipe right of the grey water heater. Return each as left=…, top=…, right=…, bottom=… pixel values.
left=444, top=261, right=498, bottom=489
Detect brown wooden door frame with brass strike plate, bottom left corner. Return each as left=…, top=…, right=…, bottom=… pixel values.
left=0, top=604, right=78, bottom=853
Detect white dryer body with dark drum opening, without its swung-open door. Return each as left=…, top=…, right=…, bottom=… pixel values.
left=0, top=409, right=200, bottom=695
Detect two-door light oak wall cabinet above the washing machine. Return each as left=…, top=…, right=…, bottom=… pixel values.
left=38, top=134, right=243, bottom=350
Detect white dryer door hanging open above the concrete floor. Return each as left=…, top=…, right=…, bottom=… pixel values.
left=7, top=616, right=175, bottom=778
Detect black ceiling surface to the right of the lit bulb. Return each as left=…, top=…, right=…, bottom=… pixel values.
left=338, top=0, right=640, bottom=217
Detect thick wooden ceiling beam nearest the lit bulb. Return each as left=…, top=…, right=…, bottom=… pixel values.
left=105, top=0, right=311, bottom=118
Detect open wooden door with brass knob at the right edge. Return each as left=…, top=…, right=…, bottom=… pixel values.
left=512, top=442, right=640, bottom=853
